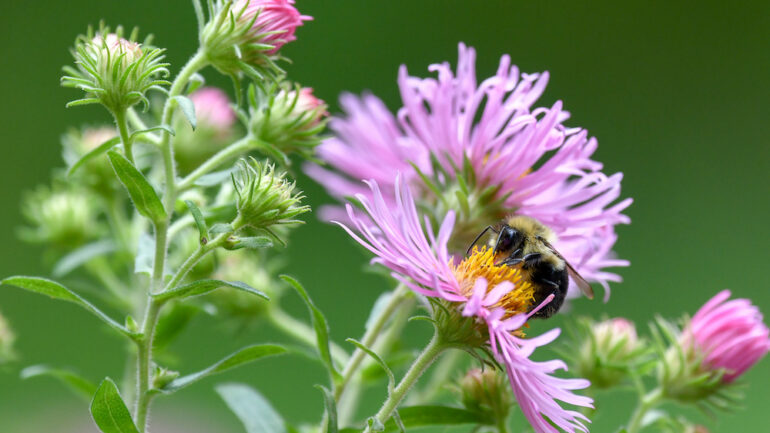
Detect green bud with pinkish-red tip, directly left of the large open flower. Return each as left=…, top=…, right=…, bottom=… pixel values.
left=249, top=86, right=328, bottom=159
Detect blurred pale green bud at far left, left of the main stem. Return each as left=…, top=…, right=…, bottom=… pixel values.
left=20, top=187, right=101, bottom=250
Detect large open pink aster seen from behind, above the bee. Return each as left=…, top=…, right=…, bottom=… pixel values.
left=306, top=44, right=631, bottom=296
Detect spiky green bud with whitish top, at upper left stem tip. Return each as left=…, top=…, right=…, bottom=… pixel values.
left=62, top=26, right=170, bottom=113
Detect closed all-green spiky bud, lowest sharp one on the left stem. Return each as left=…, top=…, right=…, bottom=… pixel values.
left=233, top=158, right=310, bottom=239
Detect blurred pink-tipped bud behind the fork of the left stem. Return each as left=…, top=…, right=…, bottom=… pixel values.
left=173, top=87, right=235, bottom=174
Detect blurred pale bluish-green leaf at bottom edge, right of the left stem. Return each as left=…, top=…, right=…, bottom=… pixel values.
left=216, top=383, right=286, bottom=433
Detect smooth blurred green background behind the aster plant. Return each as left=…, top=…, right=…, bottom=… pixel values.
left=0, top=0, right=770, bottom=433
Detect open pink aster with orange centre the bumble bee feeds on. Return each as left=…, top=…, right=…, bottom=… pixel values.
left=340, top=177, right=592, bottom=433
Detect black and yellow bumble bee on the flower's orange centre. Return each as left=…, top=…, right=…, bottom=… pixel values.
left=468, top=215, right=594, bottom=318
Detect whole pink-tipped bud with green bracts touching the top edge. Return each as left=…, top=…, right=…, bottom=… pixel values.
left=200, top=0, right=311, bottom=79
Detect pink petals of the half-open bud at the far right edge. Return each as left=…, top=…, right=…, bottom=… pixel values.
left=683, top=290, right=770, bottom=383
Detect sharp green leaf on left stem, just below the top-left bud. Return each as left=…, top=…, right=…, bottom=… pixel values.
left=107, top=150, right=167, bottom=223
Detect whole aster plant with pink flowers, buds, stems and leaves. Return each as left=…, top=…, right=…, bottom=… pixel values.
left=0, top=0, right=770, bottom=433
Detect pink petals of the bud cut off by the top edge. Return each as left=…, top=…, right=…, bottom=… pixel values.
left=238, top=0, right=313, bottom=55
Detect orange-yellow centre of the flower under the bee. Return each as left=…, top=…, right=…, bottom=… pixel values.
left=449, top=247, right=535, bottom=317
